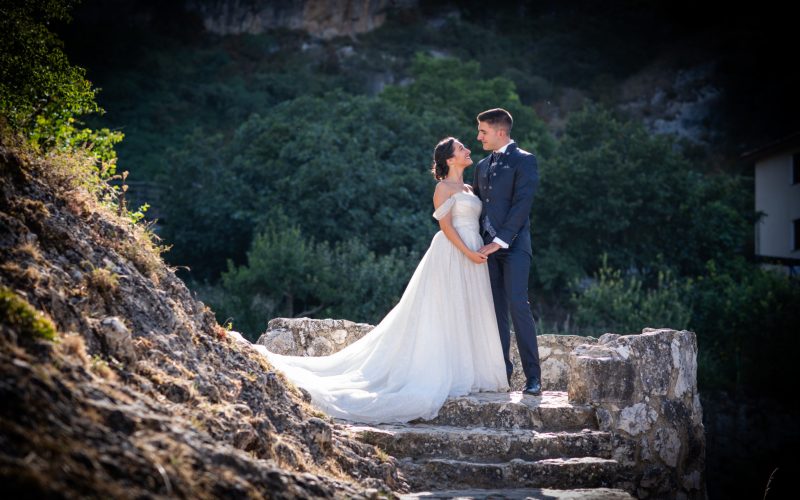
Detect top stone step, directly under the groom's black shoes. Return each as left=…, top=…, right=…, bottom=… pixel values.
left=423, top=391, right=597, bottom=432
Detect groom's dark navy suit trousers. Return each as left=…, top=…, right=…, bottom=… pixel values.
left=488, top=245, right=542, bottom=380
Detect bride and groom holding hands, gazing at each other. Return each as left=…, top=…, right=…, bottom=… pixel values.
left=256, top=108, right=541, bottom=423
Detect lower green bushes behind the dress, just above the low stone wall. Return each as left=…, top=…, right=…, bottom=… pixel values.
left=217, top=220, right=416, bottom=339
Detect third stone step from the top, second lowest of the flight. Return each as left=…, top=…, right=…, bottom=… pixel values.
left=398, top=457, right=619, bottom=490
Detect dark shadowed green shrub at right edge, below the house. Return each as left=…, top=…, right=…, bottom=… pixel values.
left=690, top=258, right=800, bottom=396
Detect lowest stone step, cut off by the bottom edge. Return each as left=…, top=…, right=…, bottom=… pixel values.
left=399, top=488, right=634, bottom=500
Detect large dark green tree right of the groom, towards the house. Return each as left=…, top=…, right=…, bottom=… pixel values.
left=532, top=107, right=751, bottom=292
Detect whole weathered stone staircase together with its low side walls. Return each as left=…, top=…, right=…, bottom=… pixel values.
left=258, top=318, right=707, bottom=500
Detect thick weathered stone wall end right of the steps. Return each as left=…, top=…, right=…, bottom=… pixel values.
left=569, top=328, right=705, bottom=498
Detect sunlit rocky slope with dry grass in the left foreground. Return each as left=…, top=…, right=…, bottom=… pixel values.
left=0, top=134, right=402, bottom=498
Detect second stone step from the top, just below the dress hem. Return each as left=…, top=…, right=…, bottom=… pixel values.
left=350, top=424, right=612, bottom=462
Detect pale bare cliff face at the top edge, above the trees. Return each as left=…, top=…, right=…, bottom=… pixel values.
left=186, top=0, right=417, bottom=38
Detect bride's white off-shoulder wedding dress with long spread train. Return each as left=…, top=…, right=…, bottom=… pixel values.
left=255, top=192, right=508, bottom=423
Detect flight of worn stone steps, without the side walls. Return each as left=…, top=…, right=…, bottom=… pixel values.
left=344, top=391, right=632, bottom=499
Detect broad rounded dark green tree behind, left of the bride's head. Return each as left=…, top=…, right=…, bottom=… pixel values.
left=164, top=92, right=438, bottom=280
